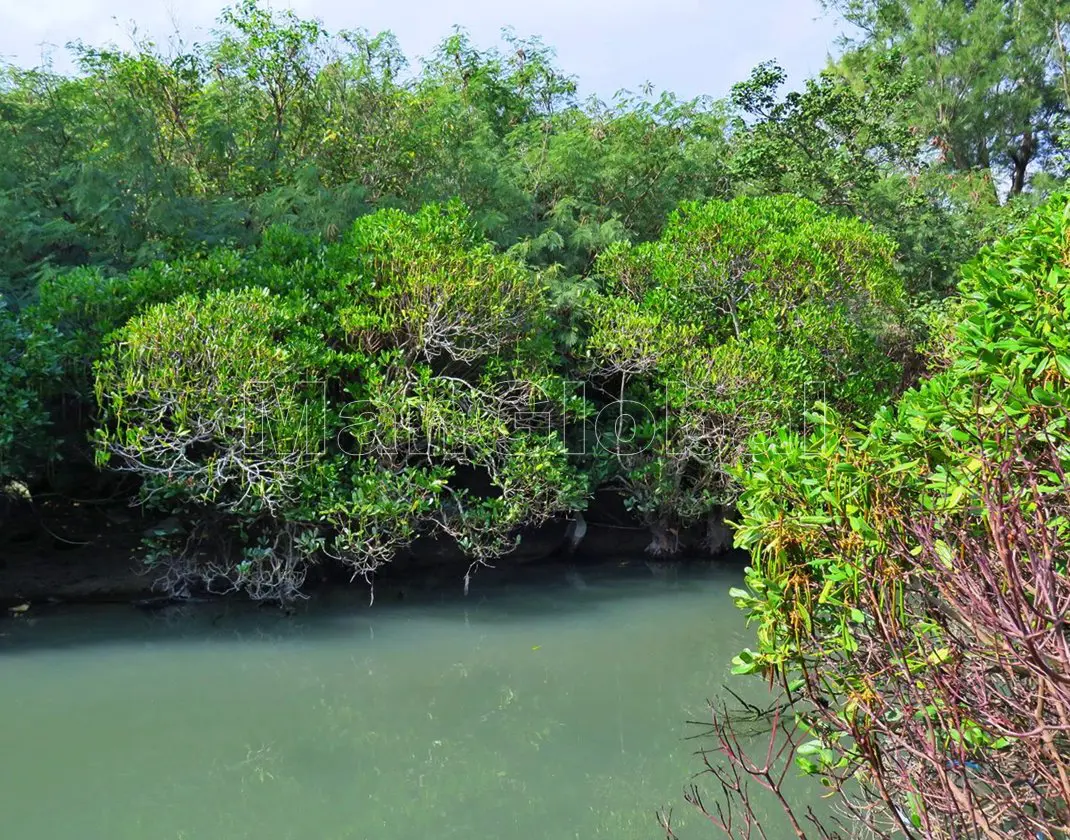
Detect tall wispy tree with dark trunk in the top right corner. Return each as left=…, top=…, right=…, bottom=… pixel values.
left=824, top=0, right=1070, bottom=196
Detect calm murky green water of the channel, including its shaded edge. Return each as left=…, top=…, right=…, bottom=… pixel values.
left=0, top=570, right=808, bottom=840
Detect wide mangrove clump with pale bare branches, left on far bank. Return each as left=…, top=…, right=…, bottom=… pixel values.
left=96, top=205, right=587, bottom=597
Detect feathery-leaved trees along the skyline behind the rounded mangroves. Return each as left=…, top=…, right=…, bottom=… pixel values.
left=0, top=0, right=725, bottom=294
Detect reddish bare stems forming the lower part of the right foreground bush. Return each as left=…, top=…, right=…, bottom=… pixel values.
left=662, top=430, right=1070, bottom=840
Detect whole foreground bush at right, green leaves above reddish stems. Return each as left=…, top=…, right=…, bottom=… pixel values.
left=719, top=196, right=1070, bottom=838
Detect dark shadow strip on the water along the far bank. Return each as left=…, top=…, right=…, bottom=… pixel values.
left=0, top=560, right=743, bottom=657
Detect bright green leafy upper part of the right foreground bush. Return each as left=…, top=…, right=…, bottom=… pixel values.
left=736, top=190, right=1070, bottom=670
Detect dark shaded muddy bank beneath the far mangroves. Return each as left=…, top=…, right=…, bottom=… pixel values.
left=0, top=494, right=738, bottom=608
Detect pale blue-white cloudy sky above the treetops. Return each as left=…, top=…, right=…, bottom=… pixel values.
left=0, top=0, right=841, bottom=98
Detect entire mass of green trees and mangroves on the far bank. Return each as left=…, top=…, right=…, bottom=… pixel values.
left=8, top=0, right=1066, bottom=616
